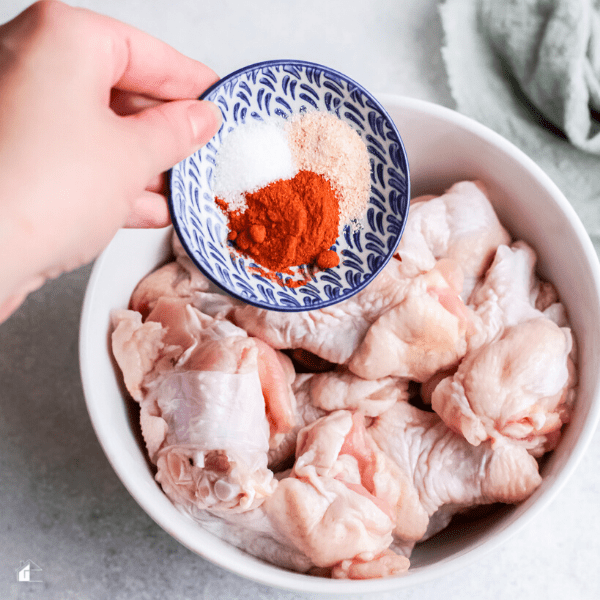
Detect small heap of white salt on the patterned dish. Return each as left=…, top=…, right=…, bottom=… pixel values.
left=214, top=121, right=297, bottom=210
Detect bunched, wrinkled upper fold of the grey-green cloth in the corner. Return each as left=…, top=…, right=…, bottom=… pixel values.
left=480, top=0, right=600, bottom=154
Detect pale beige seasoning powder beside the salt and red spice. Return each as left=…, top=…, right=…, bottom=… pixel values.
left=286, top=111, right=371, bottom=227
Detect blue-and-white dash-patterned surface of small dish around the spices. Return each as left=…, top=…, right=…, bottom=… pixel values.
left=169, top=60, right=410, bottom=311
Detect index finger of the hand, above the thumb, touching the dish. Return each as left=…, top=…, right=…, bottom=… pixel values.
left=76, top=8, right=219, bottom=100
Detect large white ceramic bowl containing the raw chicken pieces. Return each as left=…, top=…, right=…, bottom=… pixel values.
left=80, top=96, right=600, bottom=594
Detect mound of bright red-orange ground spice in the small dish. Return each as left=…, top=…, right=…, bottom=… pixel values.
left=215, top=171, right=340, bottom=272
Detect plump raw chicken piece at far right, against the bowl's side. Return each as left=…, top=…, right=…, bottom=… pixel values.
left=432, top=316, right=574, bottom=454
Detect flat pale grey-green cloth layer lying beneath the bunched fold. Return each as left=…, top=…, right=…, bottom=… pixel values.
left=440, top=0, right=600, bottom=253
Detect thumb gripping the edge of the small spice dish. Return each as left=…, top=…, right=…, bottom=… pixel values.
left=125, top=100, right=222, bottom=177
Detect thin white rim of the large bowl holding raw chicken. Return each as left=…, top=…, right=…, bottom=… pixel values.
left=79, top=94, right=600, bottom=595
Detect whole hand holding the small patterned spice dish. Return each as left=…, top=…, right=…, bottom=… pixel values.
left=0, top=1, right=221, bottom=322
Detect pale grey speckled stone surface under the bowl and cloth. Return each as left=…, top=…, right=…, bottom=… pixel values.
left=0, top=0, right=600, bottom=600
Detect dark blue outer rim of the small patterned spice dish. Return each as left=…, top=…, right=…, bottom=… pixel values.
left=167, top=58, right=411, bottom=313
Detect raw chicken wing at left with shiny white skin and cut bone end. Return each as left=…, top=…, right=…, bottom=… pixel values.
left=154, top=336, right=275, bottom=515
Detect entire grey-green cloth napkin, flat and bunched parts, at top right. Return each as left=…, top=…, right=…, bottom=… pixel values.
left=440, top=0, right=600, bottom=251
